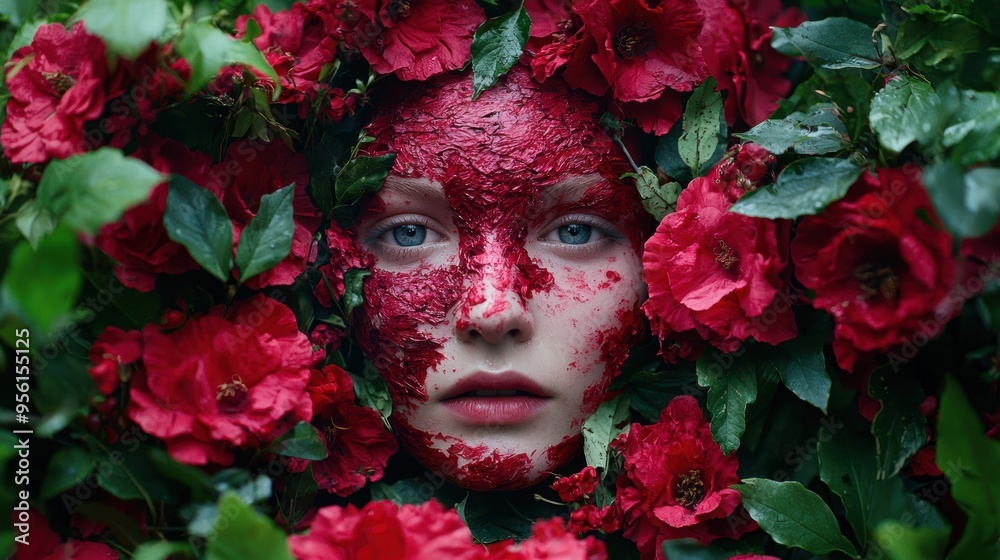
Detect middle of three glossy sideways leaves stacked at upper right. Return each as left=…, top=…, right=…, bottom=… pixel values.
left=734, top=104, right=851, bottom=155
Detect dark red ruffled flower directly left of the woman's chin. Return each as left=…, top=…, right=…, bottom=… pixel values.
left=290, top=365, right=399, bottom=497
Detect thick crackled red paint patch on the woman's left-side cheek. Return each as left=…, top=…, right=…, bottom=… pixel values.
left=357, top=266, right=462, bottom=408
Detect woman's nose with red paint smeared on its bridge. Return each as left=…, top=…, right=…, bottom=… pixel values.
left=455, top=276, right=535, bottom=344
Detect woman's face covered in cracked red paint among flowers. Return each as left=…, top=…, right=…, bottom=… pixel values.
left=354, top=70, right=645, bottom=489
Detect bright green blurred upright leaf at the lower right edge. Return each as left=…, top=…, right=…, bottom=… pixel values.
left=937, top=376, right=1000, bottom=558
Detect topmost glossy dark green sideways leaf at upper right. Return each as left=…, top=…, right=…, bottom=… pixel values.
left=771, top=17, right=882, bottom=70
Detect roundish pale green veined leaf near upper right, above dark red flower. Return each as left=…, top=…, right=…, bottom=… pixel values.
left=869, top=76, right=944, bottom=153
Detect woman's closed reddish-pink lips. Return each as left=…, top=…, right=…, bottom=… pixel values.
left=441, top=372, right=551, bottom=426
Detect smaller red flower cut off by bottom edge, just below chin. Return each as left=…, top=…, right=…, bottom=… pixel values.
left=486, top=517, right=608, bottom=560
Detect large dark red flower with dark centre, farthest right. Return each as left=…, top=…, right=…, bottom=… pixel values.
left=792, top=167, right=962, bottom=371
